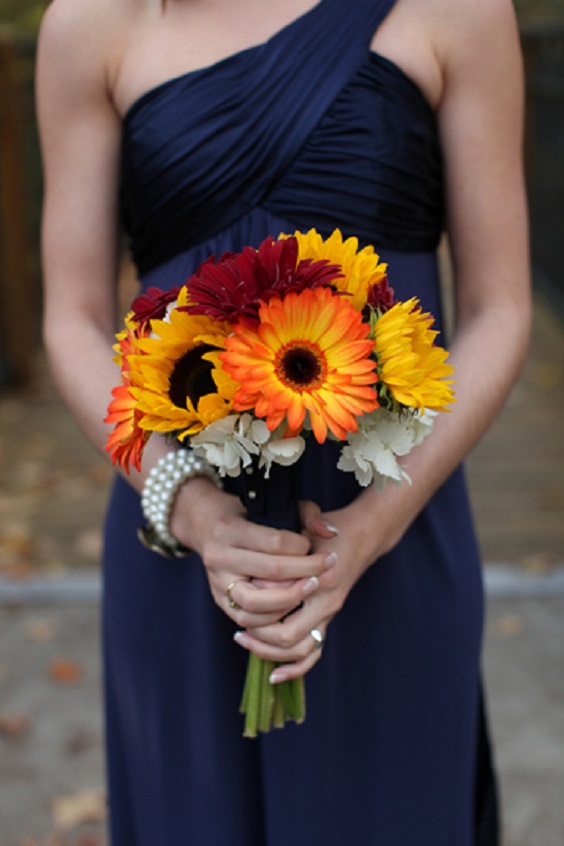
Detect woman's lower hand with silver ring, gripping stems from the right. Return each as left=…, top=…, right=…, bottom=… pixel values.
left=235, top=502, right=372, bottom=683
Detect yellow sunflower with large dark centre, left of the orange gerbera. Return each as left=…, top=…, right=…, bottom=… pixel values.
left=129, top=309, right=239, bottom=440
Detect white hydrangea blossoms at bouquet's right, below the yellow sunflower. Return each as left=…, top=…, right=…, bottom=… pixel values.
left=337, top=408, right=434, bottom=491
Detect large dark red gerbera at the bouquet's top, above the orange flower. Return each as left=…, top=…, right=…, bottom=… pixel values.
left=179, top=236, right=341, bottom=323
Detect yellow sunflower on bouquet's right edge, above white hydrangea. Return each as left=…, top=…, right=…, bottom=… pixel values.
left=374, top=297, right=454, bottom=411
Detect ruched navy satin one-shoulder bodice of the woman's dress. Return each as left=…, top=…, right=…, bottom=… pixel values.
left=121, top=0, right=443, bottom=274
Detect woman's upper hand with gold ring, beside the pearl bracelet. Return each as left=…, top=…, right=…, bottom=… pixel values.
left=171, top=478, right=334, bottom=628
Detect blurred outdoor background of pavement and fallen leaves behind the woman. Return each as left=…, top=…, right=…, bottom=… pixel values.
left=0, top=0, right=564, bottom=846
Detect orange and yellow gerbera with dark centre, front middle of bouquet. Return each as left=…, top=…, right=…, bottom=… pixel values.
left=219, top=288, right=378, bottom=443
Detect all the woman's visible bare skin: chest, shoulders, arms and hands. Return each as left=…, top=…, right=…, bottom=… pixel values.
left=37, top=0, right=530, bottom=681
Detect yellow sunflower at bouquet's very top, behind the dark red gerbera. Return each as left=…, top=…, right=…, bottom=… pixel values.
left=280, top=229, right=393, bottom=311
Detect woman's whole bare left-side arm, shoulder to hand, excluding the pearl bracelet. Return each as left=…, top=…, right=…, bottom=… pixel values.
left=37, top=0, right=332, bottom=625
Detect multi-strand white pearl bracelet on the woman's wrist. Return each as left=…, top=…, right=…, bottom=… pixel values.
left=138, top=449, right=223, bottom=558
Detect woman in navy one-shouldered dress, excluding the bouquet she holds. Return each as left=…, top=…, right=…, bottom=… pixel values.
left=38, top=0, right=529, bottom=846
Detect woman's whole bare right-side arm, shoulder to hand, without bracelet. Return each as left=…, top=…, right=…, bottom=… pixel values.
left=243, top=0, right=530, bottom=679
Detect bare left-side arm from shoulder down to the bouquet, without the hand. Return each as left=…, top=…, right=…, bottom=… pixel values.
left=37, top=2, right=124, bottom=458
